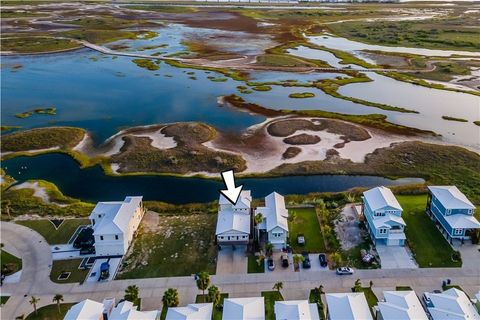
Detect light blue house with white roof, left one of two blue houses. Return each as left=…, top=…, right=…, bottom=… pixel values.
left=362, top=186, right=406, bottom=246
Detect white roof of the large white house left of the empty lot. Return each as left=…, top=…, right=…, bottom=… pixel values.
left=90, top=197, right=142, bottom=235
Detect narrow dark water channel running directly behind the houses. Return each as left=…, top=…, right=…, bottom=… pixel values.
left=2, top=154, right=423, bottom=203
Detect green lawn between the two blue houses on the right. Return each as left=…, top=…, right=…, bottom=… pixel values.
left=397, top=195, right=462, bottom=268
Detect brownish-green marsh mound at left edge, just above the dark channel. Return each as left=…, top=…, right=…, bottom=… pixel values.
left=1, top=127, right=85, bottom=152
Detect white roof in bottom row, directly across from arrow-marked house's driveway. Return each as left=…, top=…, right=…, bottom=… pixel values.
left=223, top=297, right=265, bottom=320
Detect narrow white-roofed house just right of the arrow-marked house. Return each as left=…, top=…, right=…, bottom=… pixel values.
left=255, top=192, right=288, bottom=250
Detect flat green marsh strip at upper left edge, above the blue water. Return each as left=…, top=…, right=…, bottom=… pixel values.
left=2, top=36, right=80, bottom=53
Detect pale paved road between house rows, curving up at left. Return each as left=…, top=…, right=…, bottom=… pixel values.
left=1, top=222, right=480, bottom=319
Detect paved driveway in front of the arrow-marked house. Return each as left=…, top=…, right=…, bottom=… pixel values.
left=216, top=246, right=248, bottom=274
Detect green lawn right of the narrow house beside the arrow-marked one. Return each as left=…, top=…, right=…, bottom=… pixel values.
left=288, top=208, right=326, bottom=253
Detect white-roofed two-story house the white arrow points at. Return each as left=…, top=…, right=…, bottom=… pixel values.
left=215, top=190, right=252, bottom=247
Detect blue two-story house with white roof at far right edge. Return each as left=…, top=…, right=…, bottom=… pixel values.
left=427, top=186, right=480, bottom=240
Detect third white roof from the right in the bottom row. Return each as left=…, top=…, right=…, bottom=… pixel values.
left=325, top=292, right=373, bottom=320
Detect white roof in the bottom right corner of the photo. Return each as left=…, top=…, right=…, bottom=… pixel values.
left=428, top=288, right=480, bottom=320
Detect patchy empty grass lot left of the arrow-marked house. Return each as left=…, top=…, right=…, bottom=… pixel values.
left=117, top=213, right=217, bottom=279
